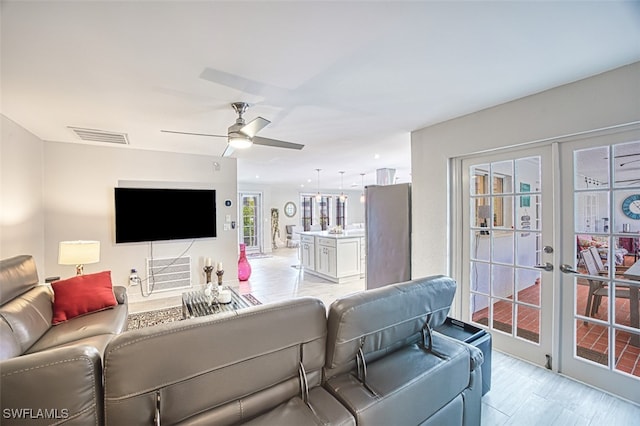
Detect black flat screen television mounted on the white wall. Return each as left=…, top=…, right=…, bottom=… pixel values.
left=115, top=188, right=217, bottom=243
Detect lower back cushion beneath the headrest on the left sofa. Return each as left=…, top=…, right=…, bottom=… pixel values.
left=0, top=286, right=51, bottom=353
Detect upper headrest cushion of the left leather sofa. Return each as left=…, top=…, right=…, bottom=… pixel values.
left=0, top=254, right=38, bottom=305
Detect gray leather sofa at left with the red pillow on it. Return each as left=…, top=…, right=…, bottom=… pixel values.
left=0, top=255, right=128, bottom=425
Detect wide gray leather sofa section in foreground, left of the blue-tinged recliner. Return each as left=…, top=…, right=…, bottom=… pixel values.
left=104, top=298, right=355, bottom=425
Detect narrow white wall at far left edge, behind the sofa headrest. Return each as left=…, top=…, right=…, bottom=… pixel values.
left=0, top=115, right=45, bottom=272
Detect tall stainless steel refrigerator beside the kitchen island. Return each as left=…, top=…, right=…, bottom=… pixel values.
left=365, top=183, right=411, bottom=289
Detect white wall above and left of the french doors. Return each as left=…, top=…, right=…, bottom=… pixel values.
left=411, top=62, right=640, bottom=277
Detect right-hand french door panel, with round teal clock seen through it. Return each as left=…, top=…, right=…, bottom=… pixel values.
left=560, top=127, right=640, bottom=404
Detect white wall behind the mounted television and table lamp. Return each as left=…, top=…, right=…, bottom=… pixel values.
left=44, top=142, right=238, bottom=302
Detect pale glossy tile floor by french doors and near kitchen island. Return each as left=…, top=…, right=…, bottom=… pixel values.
left=132, top=248, right=640, bottom=426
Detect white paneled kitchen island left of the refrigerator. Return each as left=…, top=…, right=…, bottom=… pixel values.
left=300, top=229, right=366, bottom=283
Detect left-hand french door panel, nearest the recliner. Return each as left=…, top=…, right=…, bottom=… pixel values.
left=459, top=146, right=555, bottom=365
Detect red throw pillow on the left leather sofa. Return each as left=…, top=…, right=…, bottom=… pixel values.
left=51, top=271, right=118, bottom=325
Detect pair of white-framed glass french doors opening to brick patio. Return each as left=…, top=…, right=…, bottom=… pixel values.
left=460, top=125, right=640, bottom=404
